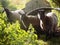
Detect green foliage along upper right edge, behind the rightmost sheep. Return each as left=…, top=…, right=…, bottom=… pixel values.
left=47, top=0, right=60, bottom=26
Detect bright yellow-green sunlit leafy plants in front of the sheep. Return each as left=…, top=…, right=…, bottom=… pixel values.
left=0, top=13, right=39, bottom=45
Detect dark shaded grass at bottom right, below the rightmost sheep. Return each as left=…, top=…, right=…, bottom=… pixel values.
left=39, top=35, right=60, bottom=45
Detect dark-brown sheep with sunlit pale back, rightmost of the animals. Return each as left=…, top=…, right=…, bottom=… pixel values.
left=40, top=10, right=58, bottom=40
